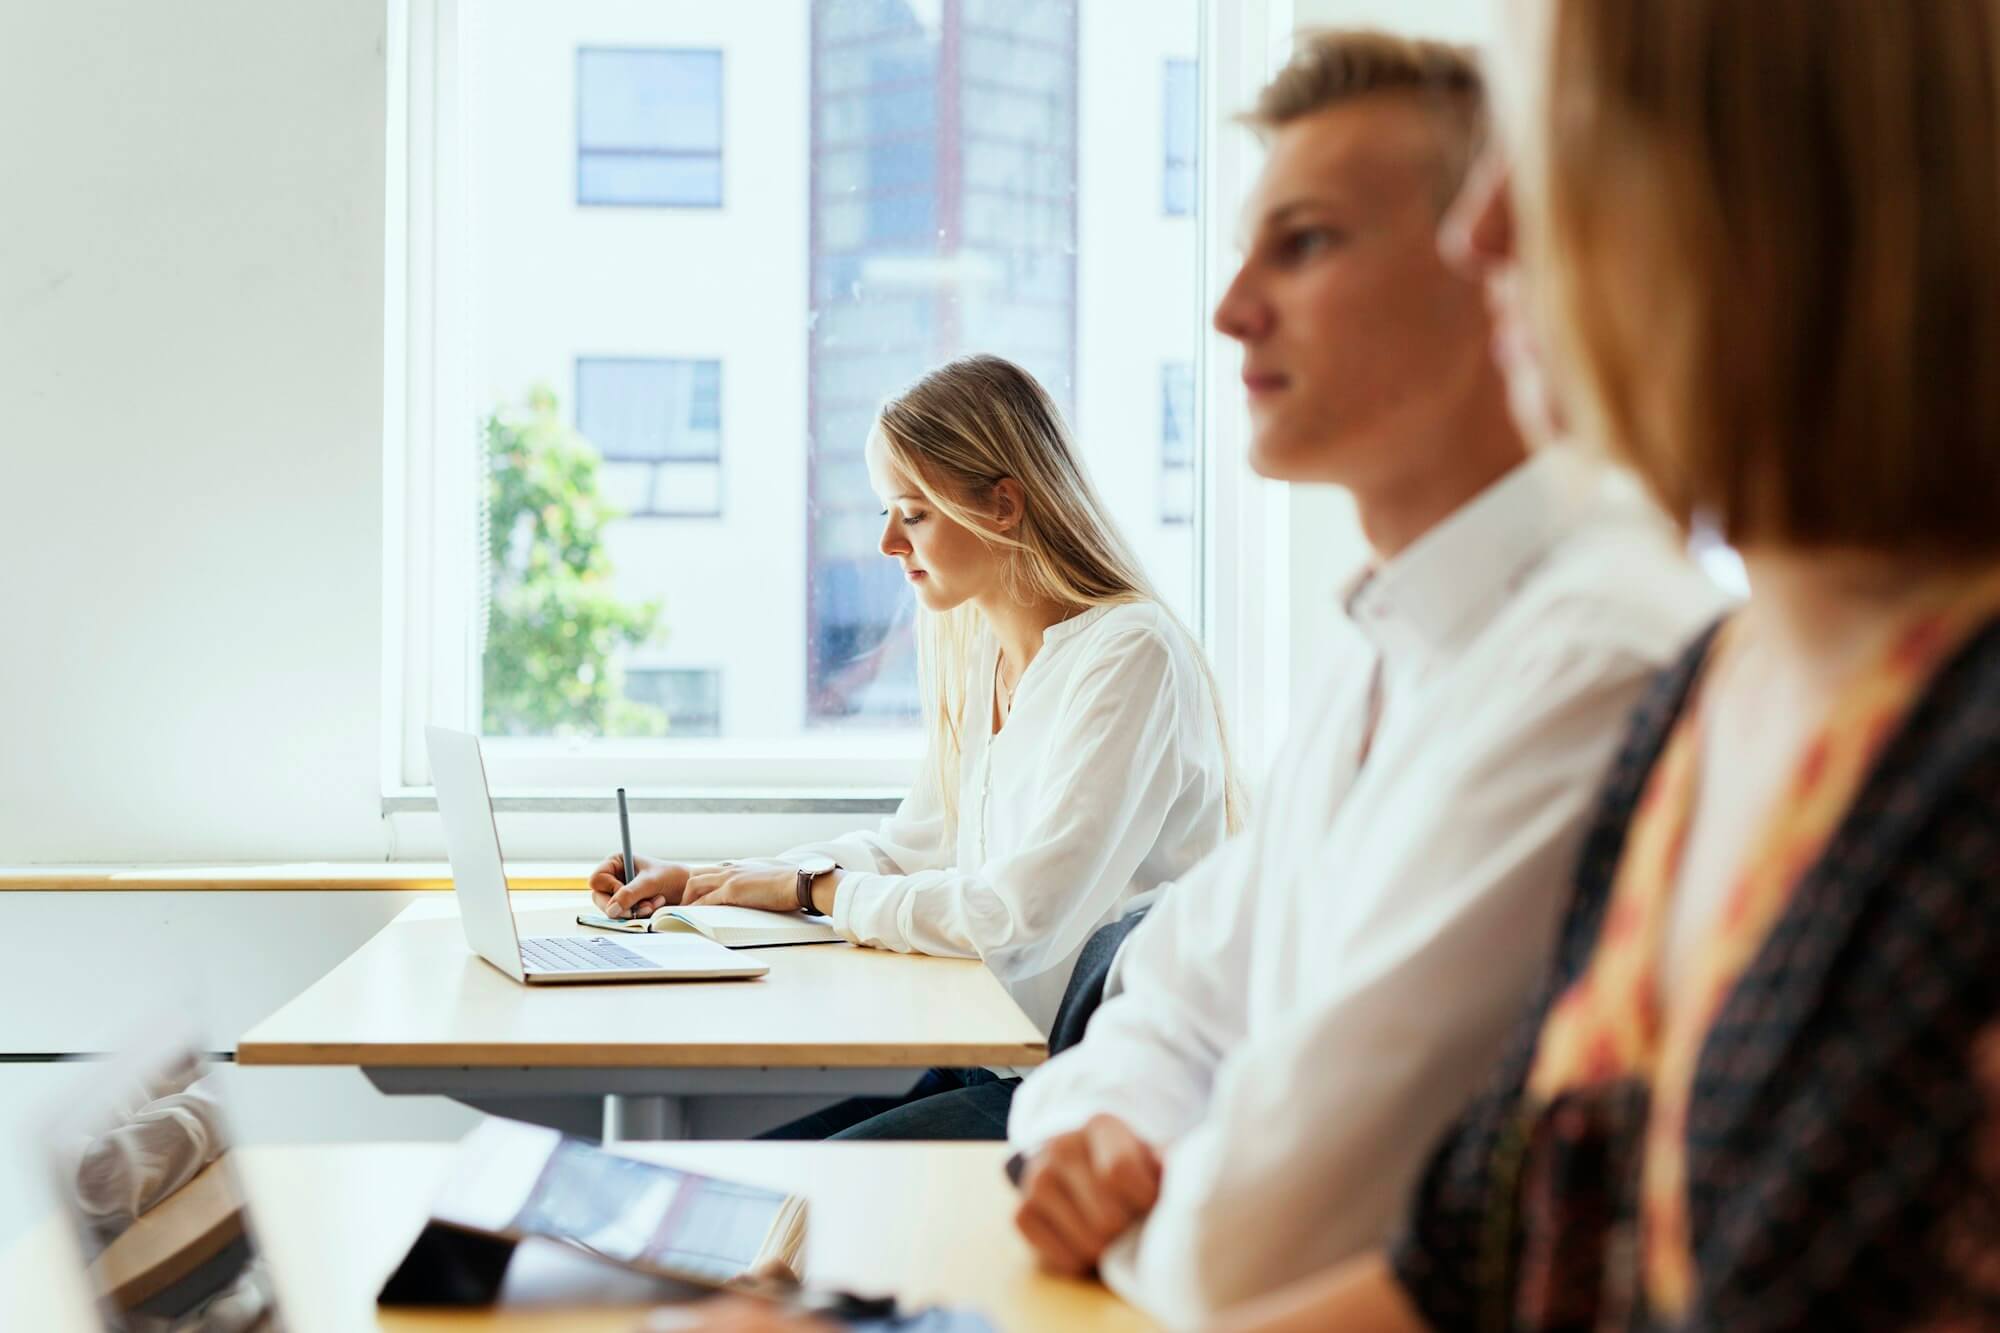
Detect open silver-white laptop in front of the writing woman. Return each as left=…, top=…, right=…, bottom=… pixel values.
left=424, top=727, right=770, bottom=987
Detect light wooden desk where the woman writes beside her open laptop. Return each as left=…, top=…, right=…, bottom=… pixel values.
left=236, top=893, right=1048, bottom=1139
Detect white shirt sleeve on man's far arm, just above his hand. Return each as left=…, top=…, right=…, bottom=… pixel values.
left=1008, top=829, right=1258, bottom=1153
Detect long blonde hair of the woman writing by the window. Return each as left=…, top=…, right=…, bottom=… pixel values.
left=876, top=356, right=1242, bottom=833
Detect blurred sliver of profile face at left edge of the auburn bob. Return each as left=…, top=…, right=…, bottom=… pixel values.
left=1440, top=0, right=1568, bottom=444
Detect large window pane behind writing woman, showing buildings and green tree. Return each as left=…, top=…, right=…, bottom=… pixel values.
left=460, top=0, right=1206, bottom=736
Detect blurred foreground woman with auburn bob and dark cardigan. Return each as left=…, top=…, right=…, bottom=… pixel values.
left=1226, top=0, right=2000, bottom=1333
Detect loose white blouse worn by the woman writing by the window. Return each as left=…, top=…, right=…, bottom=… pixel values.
left=784, top=602, right=1224, bottom=1033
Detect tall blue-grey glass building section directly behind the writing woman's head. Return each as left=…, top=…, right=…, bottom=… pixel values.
left=806, top=0, right=1080, bottom=727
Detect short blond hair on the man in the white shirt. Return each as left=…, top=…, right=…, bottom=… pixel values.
left=1238, top=28, right=1486, bottom=206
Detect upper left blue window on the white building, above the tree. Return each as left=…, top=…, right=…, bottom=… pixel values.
left=576, top=46, right=722, bottom=208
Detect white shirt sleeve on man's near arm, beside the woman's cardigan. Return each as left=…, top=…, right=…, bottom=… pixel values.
left=1102, top=636, right=1680, bottom=1325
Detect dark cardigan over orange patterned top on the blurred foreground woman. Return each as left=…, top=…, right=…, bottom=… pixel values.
left=1394, top=586, right=2000, bottom=1331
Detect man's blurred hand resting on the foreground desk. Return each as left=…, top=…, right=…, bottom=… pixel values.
left=1014, top=1115, right=1160, bottom=1277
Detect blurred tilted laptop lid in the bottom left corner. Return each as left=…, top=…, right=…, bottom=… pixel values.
left=42, top=1027, right=286, bottom=1333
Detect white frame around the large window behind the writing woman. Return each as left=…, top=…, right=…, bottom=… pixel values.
left=380, top=0, right=1308, bottom=816
